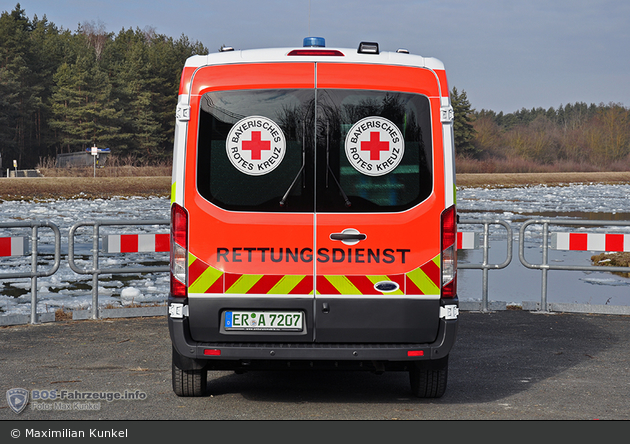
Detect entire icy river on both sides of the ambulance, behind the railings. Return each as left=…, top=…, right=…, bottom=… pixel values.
left=0, top=184, right=630, bottom=315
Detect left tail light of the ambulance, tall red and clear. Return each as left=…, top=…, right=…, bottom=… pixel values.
left=171, top=204, right=188, bottom=298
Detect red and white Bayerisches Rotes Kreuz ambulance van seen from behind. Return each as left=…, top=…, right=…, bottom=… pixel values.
left=168, top=37, right=458, bottom=397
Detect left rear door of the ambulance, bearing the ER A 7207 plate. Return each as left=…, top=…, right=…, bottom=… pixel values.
left=185, top=63, right=315, bottom=341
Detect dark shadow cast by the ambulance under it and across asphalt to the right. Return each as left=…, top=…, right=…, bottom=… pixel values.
left=207, top=310, right=619, bottom=404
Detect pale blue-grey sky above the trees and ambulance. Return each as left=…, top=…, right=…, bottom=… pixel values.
left=6, top=0, right=630, bottom=113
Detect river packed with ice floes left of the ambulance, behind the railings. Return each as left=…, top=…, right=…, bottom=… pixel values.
left=0, top=197, right=170, bottom=315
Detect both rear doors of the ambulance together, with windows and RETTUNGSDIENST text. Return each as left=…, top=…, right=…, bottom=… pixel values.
left=184, top=59, right=444, bottom=343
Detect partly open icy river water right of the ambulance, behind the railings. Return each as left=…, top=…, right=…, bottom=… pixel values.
left=457, top=184, right=630, bottom=305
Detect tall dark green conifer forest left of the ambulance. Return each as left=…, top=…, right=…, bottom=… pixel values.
left=0, top=3, right=208, bottom=168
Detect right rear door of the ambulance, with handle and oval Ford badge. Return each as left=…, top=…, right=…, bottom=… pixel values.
left=315, top=63, right=444, bottom=343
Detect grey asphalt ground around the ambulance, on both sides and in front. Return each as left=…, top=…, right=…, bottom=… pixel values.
left=0, top=310, right=630, bottom=424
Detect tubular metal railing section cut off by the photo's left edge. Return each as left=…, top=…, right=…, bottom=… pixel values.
left=0, top=221, right=61, bottom=324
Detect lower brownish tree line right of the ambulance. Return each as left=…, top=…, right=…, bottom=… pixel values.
left=451, top=88, right=630, bottom=172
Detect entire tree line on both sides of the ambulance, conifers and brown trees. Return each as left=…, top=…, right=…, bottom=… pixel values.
left=0, top=3, right=630, bottom=172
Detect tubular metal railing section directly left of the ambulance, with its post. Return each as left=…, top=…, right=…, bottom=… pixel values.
left=68, top=219, right=171, bottom=319
